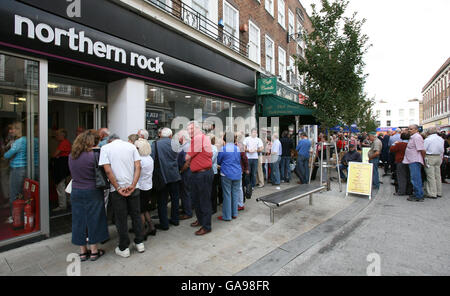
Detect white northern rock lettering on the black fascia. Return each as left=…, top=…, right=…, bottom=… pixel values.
left=14, top=14, right=164, bottom=75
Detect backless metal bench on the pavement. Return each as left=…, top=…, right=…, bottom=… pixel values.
left=256, top=184, right=327, bottom=223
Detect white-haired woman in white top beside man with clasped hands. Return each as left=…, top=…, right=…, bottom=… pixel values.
left=134, top=138, right=156, bottom=240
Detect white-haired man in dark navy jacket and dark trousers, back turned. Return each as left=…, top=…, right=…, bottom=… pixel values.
left=151, top=128, right=181, bottom=230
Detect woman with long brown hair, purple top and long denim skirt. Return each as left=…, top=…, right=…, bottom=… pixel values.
left=69, top=130, right=109, bottom=261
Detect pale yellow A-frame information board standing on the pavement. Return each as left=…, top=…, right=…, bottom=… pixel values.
left=346, top=162, right=373, bottom=199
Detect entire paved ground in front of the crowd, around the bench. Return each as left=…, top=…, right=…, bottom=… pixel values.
left=0, top=170, right=450, bottom=276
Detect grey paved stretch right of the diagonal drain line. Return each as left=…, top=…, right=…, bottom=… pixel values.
left=273, top=173, right=450, bottom=276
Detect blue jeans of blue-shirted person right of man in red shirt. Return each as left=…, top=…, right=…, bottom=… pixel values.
left=221, top=176, right=242, bottom=220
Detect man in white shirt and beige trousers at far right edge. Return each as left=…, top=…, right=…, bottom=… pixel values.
left=424, top=127, right=444, bottom=199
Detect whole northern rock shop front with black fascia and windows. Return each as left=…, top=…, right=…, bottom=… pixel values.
left=0, top=0, right=256, bottom=248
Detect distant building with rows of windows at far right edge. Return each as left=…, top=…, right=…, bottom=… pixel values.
left=422, top=58, right=450, bottom=128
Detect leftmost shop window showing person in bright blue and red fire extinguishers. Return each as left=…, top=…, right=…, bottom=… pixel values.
left=0, top=54, right=40, bottom=241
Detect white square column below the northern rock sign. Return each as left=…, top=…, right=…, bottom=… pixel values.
left=108, top=78, right=146, bottom=140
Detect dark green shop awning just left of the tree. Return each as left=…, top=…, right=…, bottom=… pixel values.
left=262, top=95, right=317, bottom=124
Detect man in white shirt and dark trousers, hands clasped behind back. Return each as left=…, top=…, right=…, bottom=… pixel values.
left=99, top=135, right=145, bottom=257
